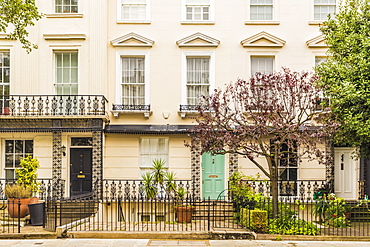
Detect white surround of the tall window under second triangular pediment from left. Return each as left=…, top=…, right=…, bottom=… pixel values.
left=181, top=51, right=216, bottom=105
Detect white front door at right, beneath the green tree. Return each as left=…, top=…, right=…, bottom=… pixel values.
left=334, top=148, right=358, bottom=200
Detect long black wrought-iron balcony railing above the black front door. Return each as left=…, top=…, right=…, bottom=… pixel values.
left=1, top=95, right=108, bottom=117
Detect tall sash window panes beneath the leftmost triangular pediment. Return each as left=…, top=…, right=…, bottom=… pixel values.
left=121, top=57, right=145, bottom=105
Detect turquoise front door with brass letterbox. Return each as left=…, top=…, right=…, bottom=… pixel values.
left=202, top=153, right=225, bottom=200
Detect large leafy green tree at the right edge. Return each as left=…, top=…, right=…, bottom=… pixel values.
left=316, top=0, right=370, bottom=156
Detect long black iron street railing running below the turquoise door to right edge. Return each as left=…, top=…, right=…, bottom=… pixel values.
left=47, top=195, right=370, bottom=236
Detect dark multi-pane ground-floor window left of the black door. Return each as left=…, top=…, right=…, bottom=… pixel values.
left=5, top=140, right=33, bottom=179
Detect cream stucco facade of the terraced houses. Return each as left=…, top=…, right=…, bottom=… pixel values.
left=0, top=0, right=362, bottom=201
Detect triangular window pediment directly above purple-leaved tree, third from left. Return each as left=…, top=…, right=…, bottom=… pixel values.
left=240, top=31, right=286, bottom=47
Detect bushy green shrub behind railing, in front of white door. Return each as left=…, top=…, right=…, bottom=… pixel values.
left=312, top=193, right=349, bottom=228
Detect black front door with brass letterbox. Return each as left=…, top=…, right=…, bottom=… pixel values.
left=70, top=148, right=92, bottom=196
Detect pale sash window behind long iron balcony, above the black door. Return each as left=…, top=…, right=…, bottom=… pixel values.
left=55, top=52, right=78, bottom=95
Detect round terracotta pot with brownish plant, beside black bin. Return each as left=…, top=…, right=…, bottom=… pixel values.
left=5, top=184, right=32, bottom=218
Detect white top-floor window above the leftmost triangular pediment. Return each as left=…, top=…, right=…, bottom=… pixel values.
left=118, top=0, right=149, bottom=21
